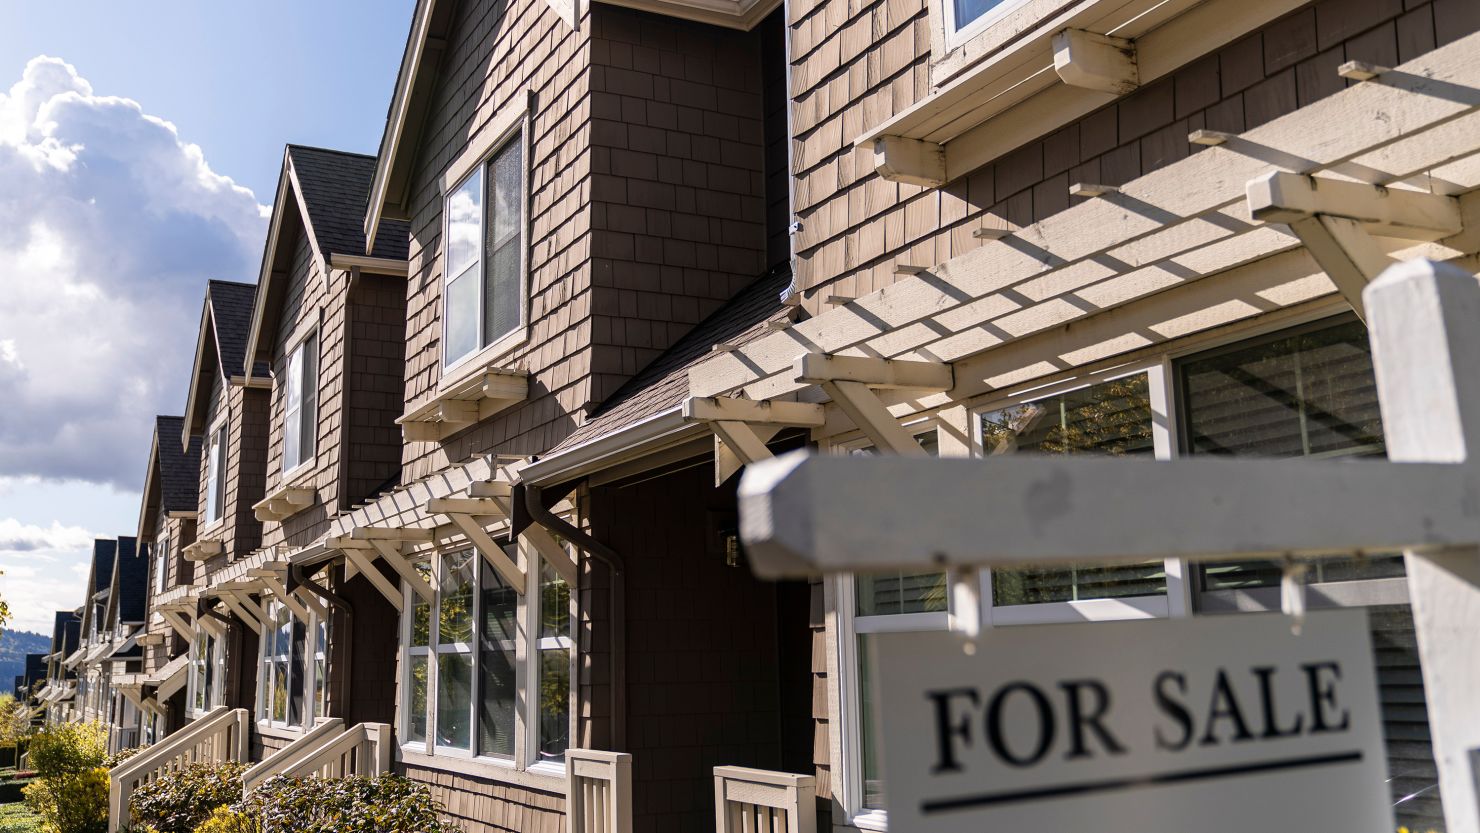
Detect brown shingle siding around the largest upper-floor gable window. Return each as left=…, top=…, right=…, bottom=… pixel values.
left=390, top=0, right=784, bottom=482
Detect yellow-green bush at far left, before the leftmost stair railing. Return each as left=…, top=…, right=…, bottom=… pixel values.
left=22, top=724, right=108, bottom=833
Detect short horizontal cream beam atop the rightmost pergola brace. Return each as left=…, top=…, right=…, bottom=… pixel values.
left=1246, top=172, right=1464, bottom=240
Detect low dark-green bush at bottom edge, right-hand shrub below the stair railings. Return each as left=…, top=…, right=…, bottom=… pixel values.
left=237, top=775, right=462, bottom=833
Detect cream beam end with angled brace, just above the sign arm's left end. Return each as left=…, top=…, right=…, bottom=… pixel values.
left=792, top=354, right=955, bottom=457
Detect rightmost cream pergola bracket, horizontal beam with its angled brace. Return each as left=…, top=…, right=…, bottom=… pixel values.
left=1246, top=172, right=1464, bottom=320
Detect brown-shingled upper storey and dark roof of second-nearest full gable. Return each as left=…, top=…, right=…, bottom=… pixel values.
left=249, top=145, right=407, bottom=549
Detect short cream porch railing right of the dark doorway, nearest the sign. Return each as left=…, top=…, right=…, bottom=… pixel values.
left=715, top=766, right=817, bottom=833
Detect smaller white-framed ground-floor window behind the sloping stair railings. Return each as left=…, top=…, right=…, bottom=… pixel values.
left=258, top=601, right=329, bottom=728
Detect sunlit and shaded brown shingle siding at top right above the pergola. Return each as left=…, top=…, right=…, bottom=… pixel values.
left=790, top=0, right=1480, bottom=312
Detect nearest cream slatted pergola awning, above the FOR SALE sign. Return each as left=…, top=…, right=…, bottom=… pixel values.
left=690, top=34, right=1480, bottom=431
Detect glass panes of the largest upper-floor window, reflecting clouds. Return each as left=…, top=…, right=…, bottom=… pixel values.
left=443, top=132, right=524, bottom=367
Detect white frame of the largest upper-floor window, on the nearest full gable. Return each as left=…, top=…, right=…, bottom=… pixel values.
left=438, top=112, right=531, bottom=378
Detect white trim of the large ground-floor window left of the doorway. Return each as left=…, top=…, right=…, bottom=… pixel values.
left=395, top=540, right=580, bottom=789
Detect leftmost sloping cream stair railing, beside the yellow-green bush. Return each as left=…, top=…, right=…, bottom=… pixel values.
left=108, top=706, right=249, bottom=832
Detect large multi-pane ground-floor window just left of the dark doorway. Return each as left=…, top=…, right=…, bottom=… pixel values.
left=401, top=544, right=574, bottom=768
